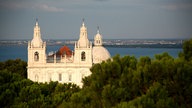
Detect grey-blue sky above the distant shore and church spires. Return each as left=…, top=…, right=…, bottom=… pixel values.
left=0, top=0, right=192, bottom=40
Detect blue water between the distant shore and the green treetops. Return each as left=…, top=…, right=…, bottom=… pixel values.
left=0, top=45, right=182, bottom=61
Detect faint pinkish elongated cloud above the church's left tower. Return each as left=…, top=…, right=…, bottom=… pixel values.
left=36, top=4, right=64, bottom=12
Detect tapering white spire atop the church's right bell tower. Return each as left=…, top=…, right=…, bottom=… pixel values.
left=77, top=20, right=90, bottom=48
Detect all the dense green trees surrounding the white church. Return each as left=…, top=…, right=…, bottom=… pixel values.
left=0, top=40, right=192, bottom=108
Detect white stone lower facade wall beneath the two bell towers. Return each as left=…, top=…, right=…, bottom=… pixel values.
left=28, top=66, right=91, bottom=86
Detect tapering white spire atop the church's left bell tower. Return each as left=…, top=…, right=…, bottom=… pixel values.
left=31, top=19, right=43, bottom=47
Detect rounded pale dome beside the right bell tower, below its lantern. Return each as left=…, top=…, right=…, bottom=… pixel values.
left=93, top=46, right=110, bottom=63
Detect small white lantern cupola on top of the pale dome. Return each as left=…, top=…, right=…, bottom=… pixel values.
left=94, top=27, right=103, bottom=46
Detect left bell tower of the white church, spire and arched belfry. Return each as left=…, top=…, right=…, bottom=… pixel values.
left=28, top=19, right=46, bottom=64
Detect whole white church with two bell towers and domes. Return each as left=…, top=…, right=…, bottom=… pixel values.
left=27, top=21, right=110, bottom=87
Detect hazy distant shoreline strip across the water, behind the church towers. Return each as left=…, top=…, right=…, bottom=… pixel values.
left=0, top=39, right=184, bottom=48
